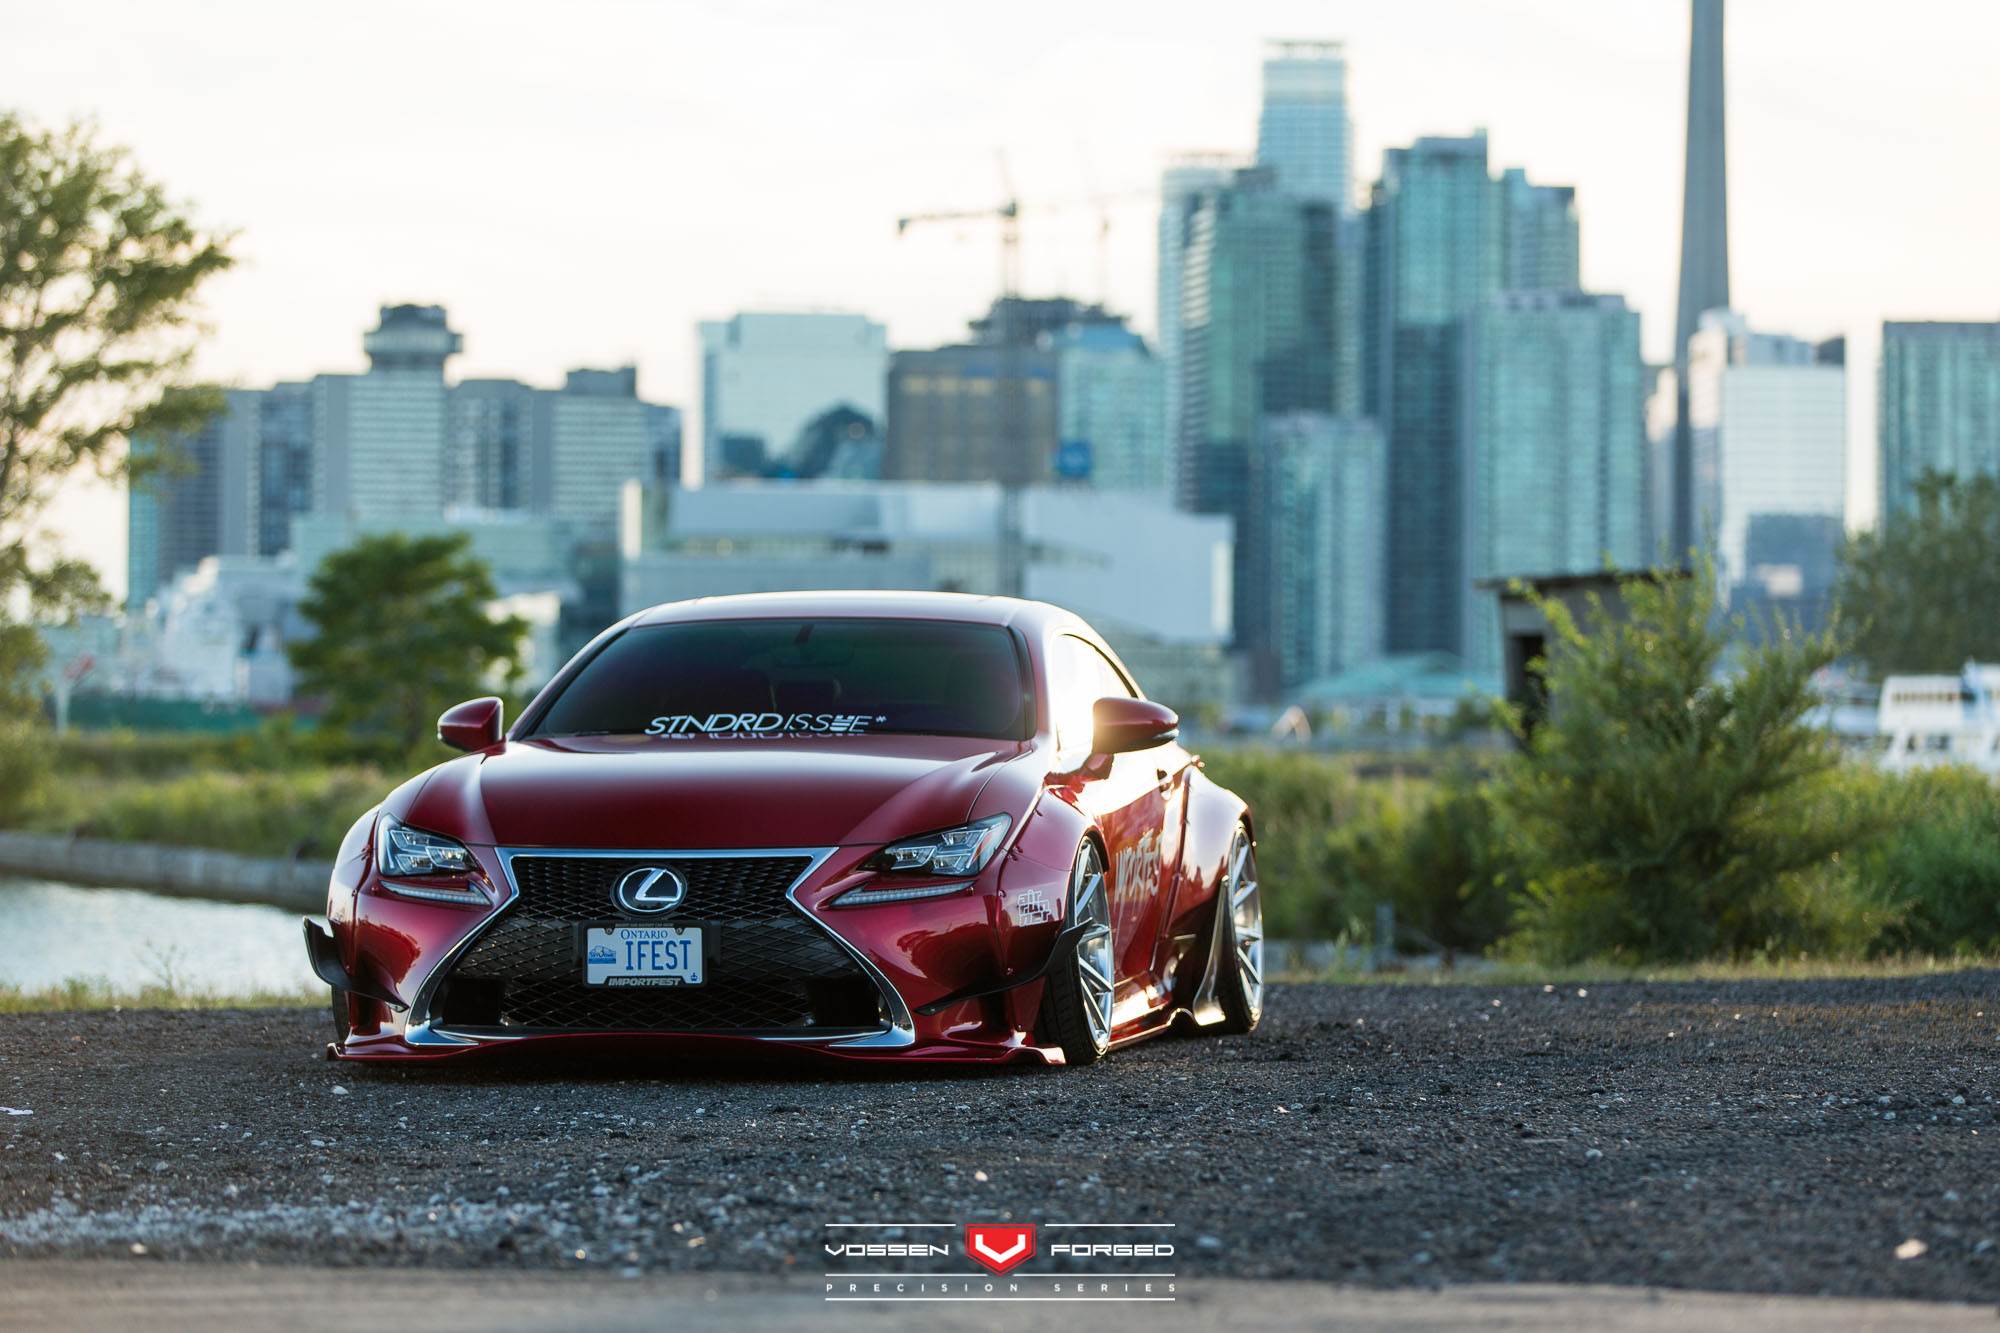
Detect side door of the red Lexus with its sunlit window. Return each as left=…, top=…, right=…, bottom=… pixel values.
left=1052, top=634, right=1180, bottom=1008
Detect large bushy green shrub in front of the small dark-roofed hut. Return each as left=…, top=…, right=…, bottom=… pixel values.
left=1496, top=566, right=1868, bottom=963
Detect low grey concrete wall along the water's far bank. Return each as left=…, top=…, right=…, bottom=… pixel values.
left=0, top=833, right=328, bottom=913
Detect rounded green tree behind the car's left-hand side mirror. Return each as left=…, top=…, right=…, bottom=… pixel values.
left=288, top=532, right=528, bottom=755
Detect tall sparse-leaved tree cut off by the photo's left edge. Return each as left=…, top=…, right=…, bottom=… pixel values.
left=0, top=110, right=230, bottom=811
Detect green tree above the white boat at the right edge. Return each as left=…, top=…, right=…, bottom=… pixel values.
left=1834, top=472, right=2000, bottom=677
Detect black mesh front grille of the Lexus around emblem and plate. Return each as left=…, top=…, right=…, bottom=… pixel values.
left=434, top=855, right=880, bottom=1033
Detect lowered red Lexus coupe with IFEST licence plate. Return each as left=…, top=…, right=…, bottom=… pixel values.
left=306, top=592, right=1264, bottom=1065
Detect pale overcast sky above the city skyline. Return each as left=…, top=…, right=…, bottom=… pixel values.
left=0, top=0, right=2000, bottom=586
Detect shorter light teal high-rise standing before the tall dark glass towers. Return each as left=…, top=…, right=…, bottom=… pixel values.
left=1254, top=412, right=1386, bottom=691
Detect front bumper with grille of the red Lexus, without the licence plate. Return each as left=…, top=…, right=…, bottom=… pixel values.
left=312, top=847, right=1066, bottom=1063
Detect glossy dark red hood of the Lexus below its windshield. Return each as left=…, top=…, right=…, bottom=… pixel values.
left=400, top=737, right=1030, bottom=851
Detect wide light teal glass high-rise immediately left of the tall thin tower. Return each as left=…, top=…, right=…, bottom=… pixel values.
left=1454, top=292, right=1648, bottom=679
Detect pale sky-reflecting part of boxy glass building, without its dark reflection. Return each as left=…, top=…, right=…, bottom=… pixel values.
left=704, top=312, right=888, bottom=484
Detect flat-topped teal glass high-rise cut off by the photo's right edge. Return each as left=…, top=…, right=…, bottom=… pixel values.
left=1876, top=320, right=2000, bottom=518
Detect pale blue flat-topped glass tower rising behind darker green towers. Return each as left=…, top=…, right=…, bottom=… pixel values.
left=1256, top=42, right=1354, bottom=216
